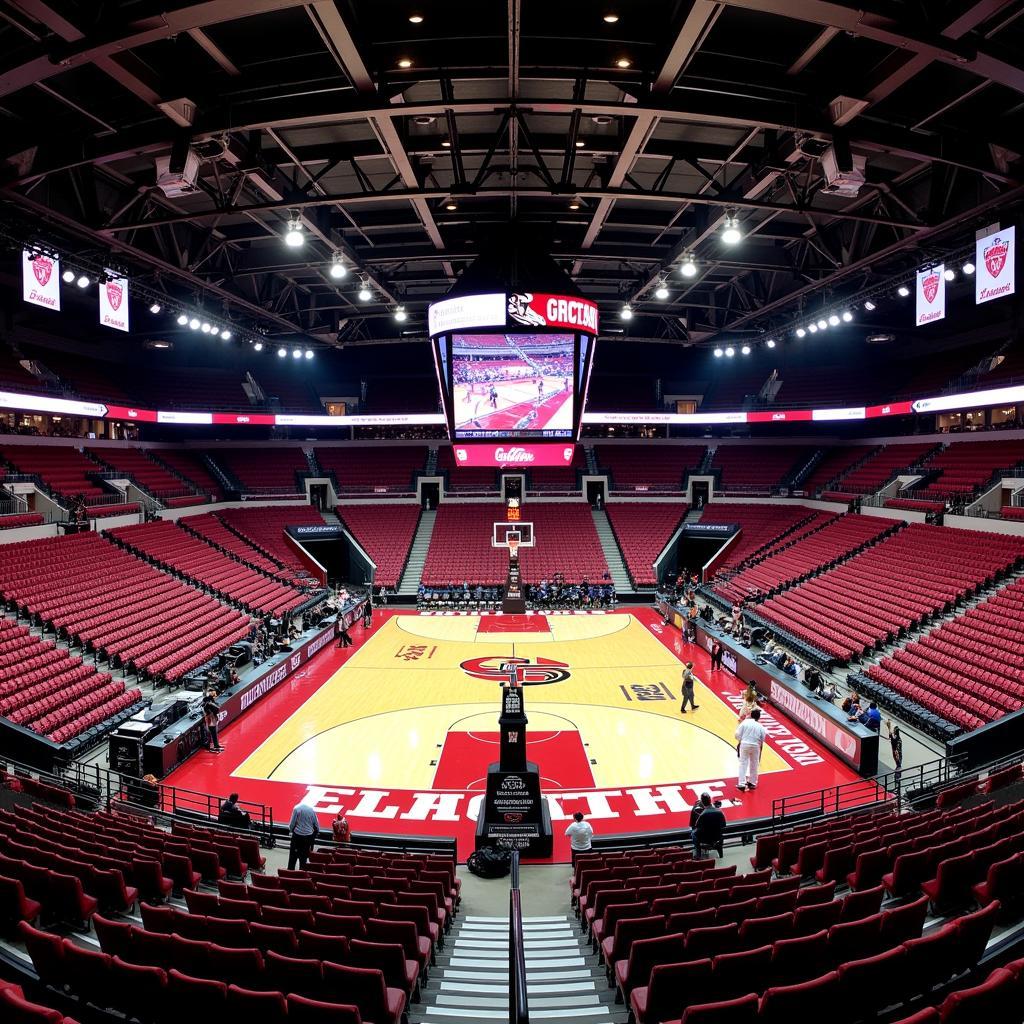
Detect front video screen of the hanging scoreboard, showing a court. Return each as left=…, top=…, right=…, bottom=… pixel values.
left=452, top=334, right=575, bottom=440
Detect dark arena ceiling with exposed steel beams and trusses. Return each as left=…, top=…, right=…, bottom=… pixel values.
left=0, top=0, right=1024, bottom=344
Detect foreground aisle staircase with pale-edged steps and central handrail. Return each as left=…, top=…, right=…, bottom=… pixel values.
left=410, top=916, right=627, bottom=1024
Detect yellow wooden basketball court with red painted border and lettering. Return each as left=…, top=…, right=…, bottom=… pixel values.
left=168, top=608, right=856, bottom=861
